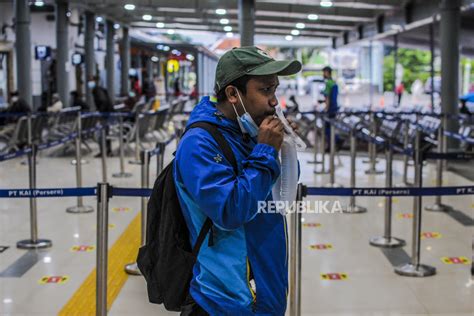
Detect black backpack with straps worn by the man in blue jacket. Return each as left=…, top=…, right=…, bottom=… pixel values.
left=137, top=122, right=237, bottom=311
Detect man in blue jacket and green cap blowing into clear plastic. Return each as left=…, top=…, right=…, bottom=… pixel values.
left=174, top=47, right=301, bottom=315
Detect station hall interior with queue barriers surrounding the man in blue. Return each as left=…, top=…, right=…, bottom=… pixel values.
left=0, top=0, right=474, bottom=316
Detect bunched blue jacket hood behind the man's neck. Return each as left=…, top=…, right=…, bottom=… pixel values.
left=186, top=96, right=241, bottom=133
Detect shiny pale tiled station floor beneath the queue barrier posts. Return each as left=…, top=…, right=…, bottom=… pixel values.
left=0, top=143, right=474, bottom=315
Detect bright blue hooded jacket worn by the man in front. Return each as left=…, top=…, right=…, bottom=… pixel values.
left=174, top=97, right=288, bottom=315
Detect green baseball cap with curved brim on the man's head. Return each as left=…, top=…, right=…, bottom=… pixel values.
left=214, top=46, right=301, bottom=94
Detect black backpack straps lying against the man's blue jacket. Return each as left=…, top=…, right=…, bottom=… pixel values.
left=185, top=122, right=239, bottom=257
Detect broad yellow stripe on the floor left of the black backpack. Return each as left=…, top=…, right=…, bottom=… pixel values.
left=58, top=214, right=141, bottom=316
